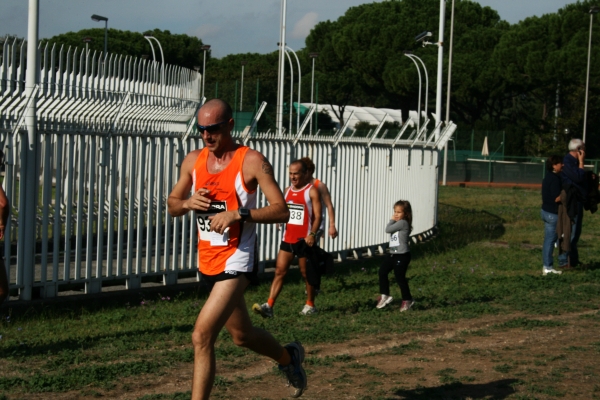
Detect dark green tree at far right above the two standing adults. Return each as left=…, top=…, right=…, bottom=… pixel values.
left=492, top=1, right=600, bottom=156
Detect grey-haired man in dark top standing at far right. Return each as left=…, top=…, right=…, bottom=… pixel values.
left=561, top=139, right=587, bottom=267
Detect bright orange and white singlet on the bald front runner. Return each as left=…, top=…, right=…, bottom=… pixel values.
left=192, top=146, right=257, bottom=275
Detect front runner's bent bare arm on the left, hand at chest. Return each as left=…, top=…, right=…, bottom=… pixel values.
left=167, top=150, right=210, bottom=217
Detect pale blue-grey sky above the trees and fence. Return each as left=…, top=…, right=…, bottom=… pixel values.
left=0, top=0, right=576, bottom=58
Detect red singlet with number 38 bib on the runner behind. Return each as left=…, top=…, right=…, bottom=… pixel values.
left=283, top=183, right=315, bottom=244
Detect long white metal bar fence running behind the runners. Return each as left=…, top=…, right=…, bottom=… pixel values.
left=0, top=38, right=456, bottom=300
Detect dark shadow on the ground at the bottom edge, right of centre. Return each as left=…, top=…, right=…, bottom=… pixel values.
left=394, top=379, right=518, bottom=400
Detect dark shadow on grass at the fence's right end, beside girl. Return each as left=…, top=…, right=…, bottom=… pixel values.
left=411, top=203, right=506, bottom=257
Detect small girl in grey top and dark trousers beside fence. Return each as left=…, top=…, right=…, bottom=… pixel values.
left=377, top=200, right=415, bottom=311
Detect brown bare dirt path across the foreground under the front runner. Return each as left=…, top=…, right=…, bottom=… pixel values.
left=38, top=311, right=600, bottom=400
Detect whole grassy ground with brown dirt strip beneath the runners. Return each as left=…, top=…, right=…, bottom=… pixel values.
left=0, top=187, right=600, bottom=400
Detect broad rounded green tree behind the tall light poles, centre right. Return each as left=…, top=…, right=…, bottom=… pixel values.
left=306, top=0, right=509, bottom=133
